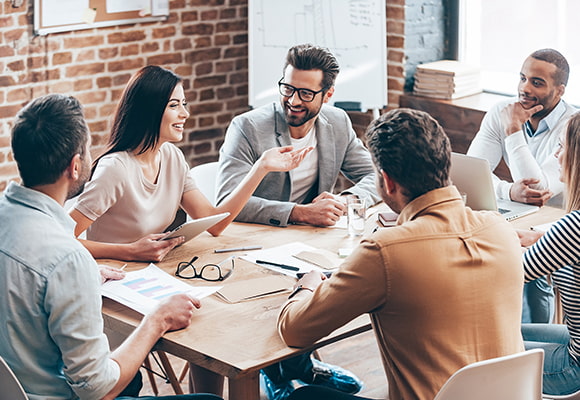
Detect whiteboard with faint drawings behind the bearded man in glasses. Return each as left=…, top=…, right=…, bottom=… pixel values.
left=248, top=0, right=387, bottom=111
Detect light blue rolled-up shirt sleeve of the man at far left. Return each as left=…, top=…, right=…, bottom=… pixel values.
left=44, top=252, right=120, bottom=399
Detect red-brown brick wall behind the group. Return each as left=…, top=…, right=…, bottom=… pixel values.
left=0, top=0, right=405, bottom=191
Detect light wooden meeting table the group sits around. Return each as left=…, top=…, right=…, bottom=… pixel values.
left=103, top=219, right=376, bottom=400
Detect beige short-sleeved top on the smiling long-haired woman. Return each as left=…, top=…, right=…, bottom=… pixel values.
left=74, top=143, right=196, bottom=243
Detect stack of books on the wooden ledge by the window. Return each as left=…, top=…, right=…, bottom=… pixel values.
left=414, top=60, right=481, bottom=99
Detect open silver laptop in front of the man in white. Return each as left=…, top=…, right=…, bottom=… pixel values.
left=449, top=153, right=540, bottom=221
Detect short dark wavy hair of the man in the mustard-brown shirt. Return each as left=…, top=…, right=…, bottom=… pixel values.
left=366, top=108, right=451, bottom=201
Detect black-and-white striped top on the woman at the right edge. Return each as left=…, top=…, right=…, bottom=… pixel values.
left=523, top=210, right=580, bottom=361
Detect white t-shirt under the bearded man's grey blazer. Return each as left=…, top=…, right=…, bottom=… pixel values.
left=290, top=128, right=318, bottom=203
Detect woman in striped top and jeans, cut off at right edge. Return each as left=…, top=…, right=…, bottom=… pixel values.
left=519, top=113, right=580, bottom=395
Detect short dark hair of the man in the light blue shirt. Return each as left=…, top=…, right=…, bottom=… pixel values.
left=12, top=94, right=89, bottom=187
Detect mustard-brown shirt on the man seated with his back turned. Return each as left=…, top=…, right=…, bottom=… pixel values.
left=278, top=186, right=524, bottom=400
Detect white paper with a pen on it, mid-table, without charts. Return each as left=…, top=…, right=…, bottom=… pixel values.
left=241, top=242, right=342, bottom=277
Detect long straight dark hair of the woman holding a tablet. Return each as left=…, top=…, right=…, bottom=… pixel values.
left=94, top=65, right=181, bottom=166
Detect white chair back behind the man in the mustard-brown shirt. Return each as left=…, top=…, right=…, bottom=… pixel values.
left=434, top=349, right=544, bottom=400
